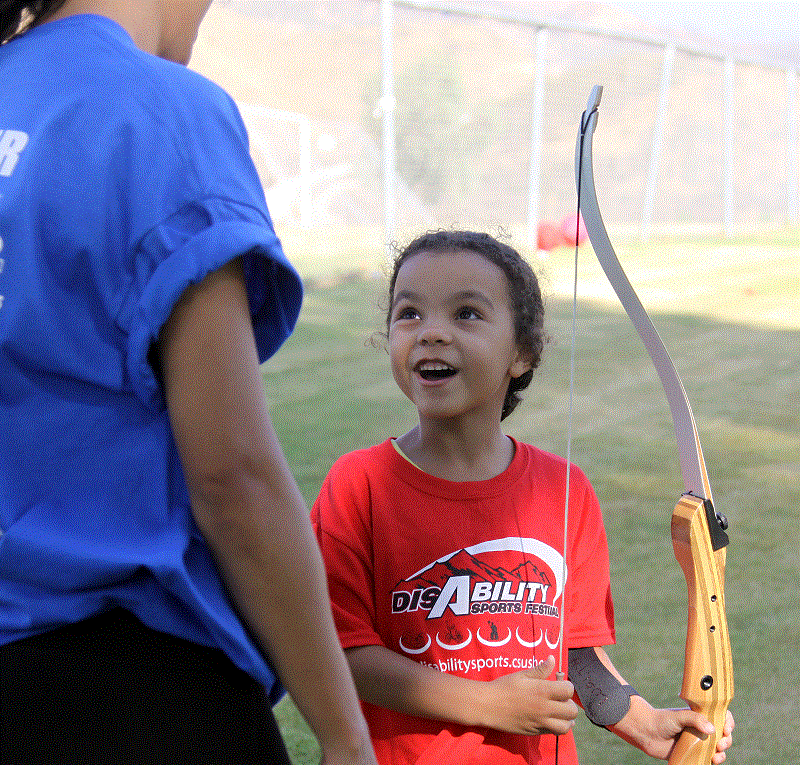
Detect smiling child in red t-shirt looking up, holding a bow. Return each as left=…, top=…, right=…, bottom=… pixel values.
left=312, top=231, right=733, bottom=765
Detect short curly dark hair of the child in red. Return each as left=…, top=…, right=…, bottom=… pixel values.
left=386, top=231, right=546, bottom=420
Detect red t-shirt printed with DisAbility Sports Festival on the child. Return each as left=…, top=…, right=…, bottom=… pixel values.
left=312, top=441, right=614, bottom=765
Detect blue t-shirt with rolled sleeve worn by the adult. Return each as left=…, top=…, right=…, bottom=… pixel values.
left=0, top=15, right=302, bottom=699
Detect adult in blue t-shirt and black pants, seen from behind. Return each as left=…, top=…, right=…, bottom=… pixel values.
left=0, top=0, right=374, bottom=765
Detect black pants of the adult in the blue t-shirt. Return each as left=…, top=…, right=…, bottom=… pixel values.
left=0, top=609, right=290, bottom=765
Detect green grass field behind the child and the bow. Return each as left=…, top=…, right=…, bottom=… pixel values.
left=264, top=231, right=800, bottom=765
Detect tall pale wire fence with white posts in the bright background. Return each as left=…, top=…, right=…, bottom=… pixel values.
left=192, top=0, right=800, bottom=271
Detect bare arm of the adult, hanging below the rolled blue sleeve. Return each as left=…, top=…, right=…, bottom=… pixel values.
left=159, top=260, right=375, bottom=765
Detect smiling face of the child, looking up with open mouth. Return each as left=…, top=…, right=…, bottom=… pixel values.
left=389, top=251, right=530, bottom=422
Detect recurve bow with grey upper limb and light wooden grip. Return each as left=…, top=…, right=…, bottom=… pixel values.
left=575, top=86, right=733, bottom=765
